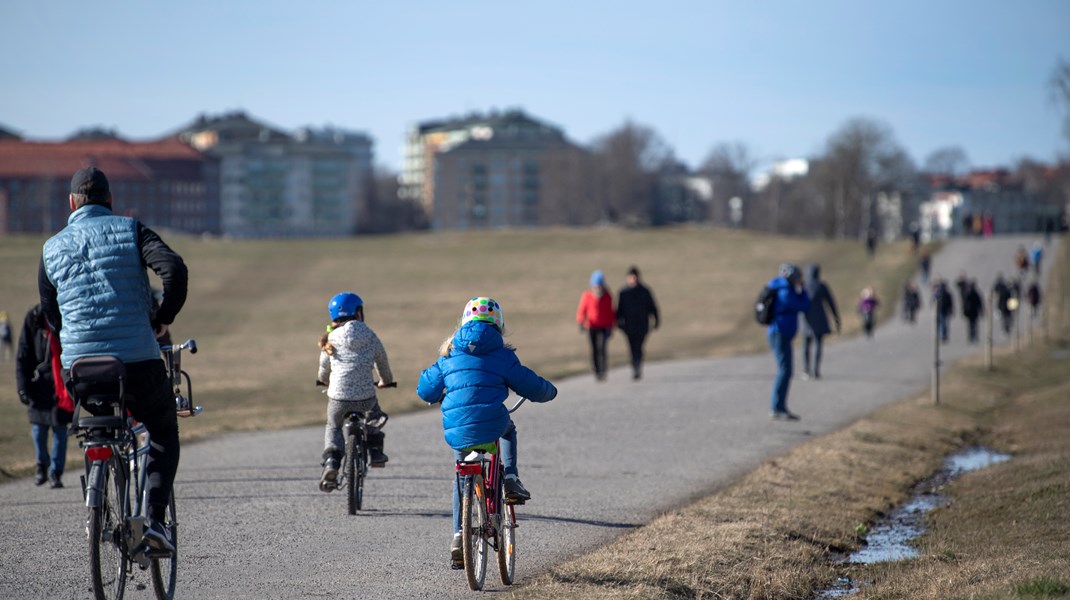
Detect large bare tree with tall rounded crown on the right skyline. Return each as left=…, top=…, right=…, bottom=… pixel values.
left=812, top=118, right=914, bottom=237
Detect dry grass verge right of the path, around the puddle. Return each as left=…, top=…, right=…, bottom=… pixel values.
left=514, top=238, right=1070, bottom=600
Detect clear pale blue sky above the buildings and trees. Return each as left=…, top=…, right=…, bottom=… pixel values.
left=0, top=0, right=1070, bottom=169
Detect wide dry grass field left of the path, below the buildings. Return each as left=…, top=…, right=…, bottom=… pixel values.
left=0, top=228, right=914, bottom=479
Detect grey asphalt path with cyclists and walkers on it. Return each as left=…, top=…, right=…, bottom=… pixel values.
left=0, top=236, right=1056, bottom=599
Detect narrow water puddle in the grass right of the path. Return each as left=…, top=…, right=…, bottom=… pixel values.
left=816, top=447, right=1010, bottom=600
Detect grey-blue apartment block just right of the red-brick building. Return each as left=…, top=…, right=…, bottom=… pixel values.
left=178, top=112, right=372, bottom=237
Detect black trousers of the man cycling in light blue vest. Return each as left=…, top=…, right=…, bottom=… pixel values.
left=69, top=360, right=180, bottom=520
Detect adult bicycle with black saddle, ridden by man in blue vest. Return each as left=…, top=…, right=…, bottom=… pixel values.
left=71, top=340, right=202, bottom=600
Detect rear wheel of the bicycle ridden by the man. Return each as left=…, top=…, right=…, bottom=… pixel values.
left=87, top=456, right=129, bottom=600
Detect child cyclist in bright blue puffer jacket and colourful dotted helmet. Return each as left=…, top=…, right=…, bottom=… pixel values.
left=416, top=297, right=557, bottom=567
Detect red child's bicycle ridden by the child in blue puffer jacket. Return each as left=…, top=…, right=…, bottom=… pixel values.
left=455, top=398, right=528, bottom=591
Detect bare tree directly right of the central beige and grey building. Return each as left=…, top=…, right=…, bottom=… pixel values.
left=592, top=121, right=674, bottom=224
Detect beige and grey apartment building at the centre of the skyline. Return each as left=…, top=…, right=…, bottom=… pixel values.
left=398, top=110, right=599, bottom=229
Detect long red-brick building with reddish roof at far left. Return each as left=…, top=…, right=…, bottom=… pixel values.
left=0, top=137, right=219, bottom=234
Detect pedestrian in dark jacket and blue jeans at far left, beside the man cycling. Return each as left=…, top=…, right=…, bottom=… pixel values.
left=15, top=304, right=74, bottom=489
